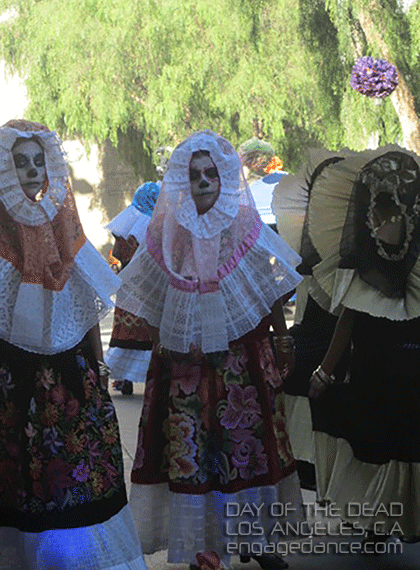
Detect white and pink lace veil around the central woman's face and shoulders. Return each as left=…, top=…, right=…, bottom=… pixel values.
left=117, top=131, right=301, bottom=353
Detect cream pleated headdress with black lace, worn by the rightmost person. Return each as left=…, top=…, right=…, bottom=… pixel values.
left=273, top=145, right=420, bottom=320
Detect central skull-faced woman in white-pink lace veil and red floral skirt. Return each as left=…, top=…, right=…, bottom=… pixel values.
left=117, top=131, right=303, bottom=570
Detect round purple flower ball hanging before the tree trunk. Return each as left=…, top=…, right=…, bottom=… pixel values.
left=350, top=56, right=398, bottom=99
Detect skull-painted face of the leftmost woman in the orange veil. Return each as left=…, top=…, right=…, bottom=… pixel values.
left=12, top=139, right=46, bottom=201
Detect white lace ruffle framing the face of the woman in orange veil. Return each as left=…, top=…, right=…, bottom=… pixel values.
left=0, top=127, right=68, bottom=226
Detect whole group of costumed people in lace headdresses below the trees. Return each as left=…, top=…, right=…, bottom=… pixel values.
left=0, top=116, right=420, bottom=570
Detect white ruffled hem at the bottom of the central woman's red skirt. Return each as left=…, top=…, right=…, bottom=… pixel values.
left=129, top=472, right=305, bottom=567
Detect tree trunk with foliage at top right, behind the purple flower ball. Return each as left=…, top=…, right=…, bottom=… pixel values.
left=300, top=0, right=420, bottom=154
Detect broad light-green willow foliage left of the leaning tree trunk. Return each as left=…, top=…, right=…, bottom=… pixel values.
left=0, top=0, right=339, bottom=168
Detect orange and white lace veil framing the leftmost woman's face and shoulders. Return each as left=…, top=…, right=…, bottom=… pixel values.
left=0, top=120, right=119, bottom=354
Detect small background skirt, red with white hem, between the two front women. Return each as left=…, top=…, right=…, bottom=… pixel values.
left=105, top=307, right=152, bottom=382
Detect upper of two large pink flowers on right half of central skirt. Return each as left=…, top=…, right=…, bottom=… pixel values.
left=220, top=384, right=261, bottom=429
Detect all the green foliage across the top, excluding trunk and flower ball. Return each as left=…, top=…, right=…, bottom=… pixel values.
left=0, top=0, right=420, bottom=170
